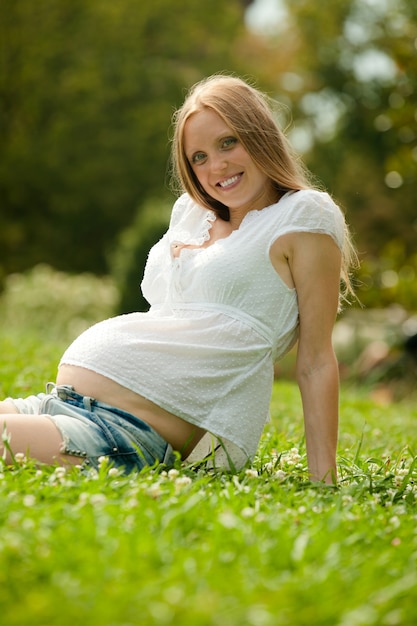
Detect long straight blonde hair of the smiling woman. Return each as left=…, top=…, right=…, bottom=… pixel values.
left=171, top=74, right=357, bottom=295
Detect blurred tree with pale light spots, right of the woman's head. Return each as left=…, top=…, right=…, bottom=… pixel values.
left=260, top=0, right=417, bottom=305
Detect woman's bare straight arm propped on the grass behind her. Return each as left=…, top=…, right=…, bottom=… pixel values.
left=271, top=233, right=341, bottom=484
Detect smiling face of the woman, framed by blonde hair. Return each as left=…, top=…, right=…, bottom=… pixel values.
left=184, top=108, right=277, bottom=214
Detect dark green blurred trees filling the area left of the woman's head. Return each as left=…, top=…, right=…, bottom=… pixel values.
left=0, top=0, right=256, bottom=282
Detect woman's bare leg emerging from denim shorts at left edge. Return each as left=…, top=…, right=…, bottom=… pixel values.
left=0, top=410, right=82, bottom=465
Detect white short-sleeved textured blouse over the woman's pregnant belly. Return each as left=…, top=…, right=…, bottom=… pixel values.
left=61, top=190, right=344, bottom=468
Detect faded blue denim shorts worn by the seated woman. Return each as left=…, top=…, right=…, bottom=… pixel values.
left=7, top=383, right=176, bottom=473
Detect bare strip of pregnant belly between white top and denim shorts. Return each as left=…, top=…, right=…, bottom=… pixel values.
left=56, top=365, right=205, bottom=458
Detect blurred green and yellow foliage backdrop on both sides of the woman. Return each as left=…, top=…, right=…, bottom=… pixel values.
left=0, top=0, right=417, bottom=310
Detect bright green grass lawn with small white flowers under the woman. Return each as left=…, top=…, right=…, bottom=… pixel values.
left=0, top=329, right=417, bottom=626
